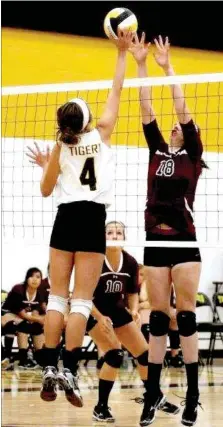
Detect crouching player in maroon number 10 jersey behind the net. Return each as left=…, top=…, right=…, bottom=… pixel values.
left=77, top=221, right=178, bottom=422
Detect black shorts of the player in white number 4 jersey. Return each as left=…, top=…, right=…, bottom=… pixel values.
left=50, top=201, right=106, bottom=254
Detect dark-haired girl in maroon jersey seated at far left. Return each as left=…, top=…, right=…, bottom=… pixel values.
left=1, top=267, right=44, bottom=369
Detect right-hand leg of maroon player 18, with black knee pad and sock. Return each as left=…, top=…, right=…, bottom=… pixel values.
left=172, top=262, right=201, bottom=402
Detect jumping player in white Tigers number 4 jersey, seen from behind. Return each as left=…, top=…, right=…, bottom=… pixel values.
left=26, top=32, right=133, bottom=406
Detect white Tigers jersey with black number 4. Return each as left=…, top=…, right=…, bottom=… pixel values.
left=56, top=129, right=114, bottom=206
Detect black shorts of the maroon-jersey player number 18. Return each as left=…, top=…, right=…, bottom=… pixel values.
left=144, top=232, right=201, bottom=267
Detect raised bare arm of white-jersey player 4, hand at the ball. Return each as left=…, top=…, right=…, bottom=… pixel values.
left=97, top=32, right=132, bottom=145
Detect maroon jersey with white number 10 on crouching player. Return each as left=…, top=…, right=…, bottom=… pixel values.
left=93, top=251, right=138, bottom=315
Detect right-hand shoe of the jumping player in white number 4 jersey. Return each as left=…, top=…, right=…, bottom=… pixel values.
left=57, top=368, right=83, bottom=408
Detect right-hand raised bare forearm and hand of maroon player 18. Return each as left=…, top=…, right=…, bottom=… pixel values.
left=154, top=36, right=191, bottom=124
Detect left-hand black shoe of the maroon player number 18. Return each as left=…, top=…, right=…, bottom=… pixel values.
left=140, top=392, right=166, bottom=427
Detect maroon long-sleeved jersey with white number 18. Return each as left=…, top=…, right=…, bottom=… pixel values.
left=143, top=120, right=203, bottom=234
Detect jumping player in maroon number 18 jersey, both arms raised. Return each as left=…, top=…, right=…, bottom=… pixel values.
left=131, top=34, right=207, bottom=426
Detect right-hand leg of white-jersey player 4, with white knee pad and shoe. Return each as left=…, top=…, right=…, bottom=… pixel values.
left=57, top=251, right=104, bottom=407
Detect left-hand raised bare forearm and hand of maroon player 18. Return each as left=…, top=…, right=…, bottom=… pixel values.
left=130, top=33, right=155, bottom=125
